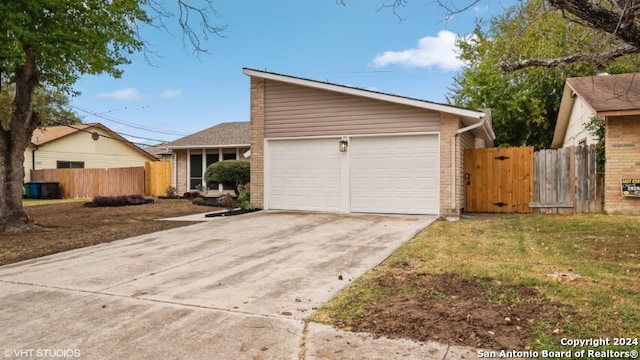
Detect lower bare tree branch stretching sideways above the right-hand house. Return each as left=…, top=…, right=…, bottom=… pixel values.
left=500, top=44, right=640, bottom=72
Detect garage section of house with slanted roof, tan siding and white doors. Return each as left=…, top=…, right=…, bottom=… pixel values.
left=244, top=68, right=495, bottom=216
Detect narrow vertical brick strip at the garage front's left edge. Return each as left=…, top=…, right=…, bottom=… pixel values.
left=250, top=77, right=265, bottom=208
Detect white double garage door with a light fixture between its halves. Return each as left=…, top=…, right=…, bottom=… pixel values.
left=265, top=135, right=439, bottom=214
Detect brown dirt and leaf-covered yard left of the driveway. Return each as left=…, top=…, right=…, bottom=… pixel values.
left=0, top=199, right=209, bottom=265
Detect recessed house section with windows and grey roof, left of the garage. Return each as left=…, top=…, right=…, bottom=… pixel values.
left=163, top=121, right=250, bottom=196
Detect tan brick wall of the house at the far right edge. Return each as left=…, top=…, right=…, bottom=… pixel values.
left=604, top=116, right=640, bottom=215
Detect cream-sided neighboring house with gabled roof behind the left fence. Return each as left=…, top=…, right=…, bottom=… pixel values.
left=24, top=123, right=156, bottom=182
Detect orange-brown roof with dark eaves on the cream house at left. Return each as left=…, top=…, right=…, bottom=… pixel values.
left=31, top=123, right=156, bottom=160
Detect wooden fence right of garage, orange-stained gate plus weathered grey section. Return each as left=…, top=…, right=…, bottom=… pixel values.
left=465, top=145, right=604, bottom=213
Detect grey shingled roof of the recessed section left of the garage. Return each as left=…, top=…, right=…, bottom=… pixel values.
left=163, top=121, right=251, bottom=149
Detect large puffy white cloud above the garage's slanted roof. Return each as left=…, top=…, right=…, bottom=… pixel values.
left=373, top=30, right=463, bottom=71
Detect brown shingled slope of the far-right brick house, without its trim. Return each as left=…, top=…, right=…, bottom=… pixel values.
left=567, top=73, right=640, bottom=116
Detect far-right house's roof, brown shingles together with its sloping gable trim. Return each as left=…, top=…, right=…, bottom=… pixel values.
left=551, top=73, right=640, bottom=149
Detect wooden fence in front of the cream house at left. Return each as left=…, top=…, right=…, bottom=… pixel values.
left=31, top=161, right=171, bottom=199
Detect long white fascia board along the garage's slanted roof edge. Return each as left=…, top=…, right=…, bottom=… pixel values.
left=242, top=68, right=485, bottom=119
